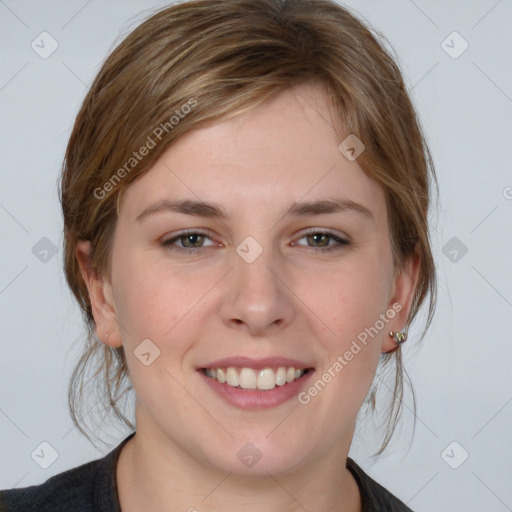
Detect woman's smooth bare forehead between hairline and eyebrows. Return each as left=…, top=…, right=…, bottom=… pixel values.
left=121, top=84, right=385, bottom=217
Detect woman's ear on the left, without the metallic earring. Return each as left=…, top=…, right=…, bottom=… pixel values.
left=75, top=240, right=123, bottom=347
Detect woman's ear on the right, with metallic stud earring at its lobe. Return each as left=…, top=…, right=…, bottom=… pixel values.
left=382, top=246, right=421, bottom=352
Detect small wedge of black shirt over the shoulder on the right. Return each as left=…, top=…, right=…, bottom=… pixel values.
left=346, top=457, right=413, bottom=512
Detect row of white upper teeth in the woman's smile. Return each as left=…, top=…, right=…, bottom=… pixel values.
left=203, top=366, right=306, bottom=390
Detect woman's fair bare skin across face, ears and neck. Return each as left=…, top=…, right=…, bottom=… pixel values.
left=76, top=84, right=419, bottom=512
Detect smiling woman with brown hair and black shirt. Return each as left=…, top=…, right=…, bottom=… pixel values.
left=0, top=0, right=435, bottom=512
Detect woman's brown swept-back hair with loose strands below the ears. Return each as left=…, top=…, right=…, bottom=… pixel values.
left=60, top=0, right=436, bottom=453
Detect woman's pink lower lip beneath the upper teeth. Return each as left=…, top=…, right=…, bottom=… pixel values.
left=199, top=370, right=314, bottom=410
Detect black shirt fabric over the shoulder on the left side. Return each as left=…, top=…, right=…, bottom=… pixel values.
left=0, top=434, right=134, bottom=512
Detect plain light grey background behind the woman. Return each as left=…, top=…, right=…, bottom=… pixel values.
left=0, top=0, right=512, bottom=512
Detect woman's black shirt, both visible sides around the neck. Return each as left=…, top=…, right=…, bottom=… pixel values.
left=0, top=432, right=412, bottom=512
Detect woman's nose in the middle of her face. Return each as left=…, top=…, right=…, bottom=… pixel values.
left=220, top=246, right=296, bottom=336
